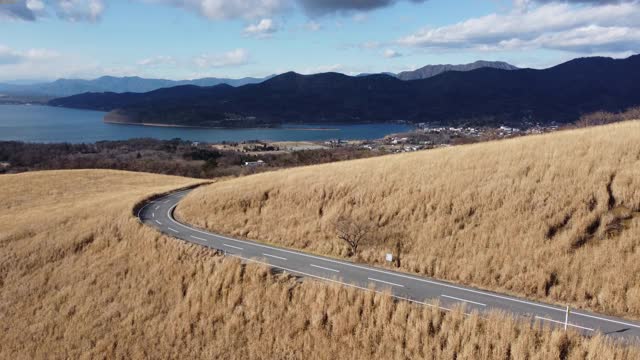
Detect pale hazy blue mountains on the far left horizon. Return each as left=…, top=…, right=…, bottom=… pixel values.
left=0, top=75, right=273, bottom=97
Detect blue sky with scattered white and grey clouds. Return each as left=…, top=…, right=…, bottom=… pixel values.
left=0, top=0, right=640, bottom=82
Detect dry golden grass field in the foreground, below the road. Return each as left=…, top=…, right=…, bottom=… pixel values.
left=0, top=170, right=640, bottom=360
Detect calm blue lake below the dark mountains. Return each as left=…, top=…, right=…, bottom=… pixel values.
left=0, top=105, right=411, bottom=143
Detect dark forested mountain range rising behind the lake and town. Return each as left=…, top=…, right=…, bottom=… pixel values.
left=50, top=55, right=640, bottom=127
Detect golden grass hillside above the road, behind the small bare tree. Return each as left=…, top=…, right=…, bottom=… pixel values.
left=178, top=122, right=640, bottom=318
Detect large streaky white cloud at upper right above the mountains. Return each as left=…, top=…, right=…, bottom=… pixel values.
left=398, top=1, right=640, bottom=53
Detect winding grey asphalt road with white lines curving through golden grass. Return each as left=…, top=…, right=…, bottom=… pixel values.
left=137, top=190, right=640, bottom=341
